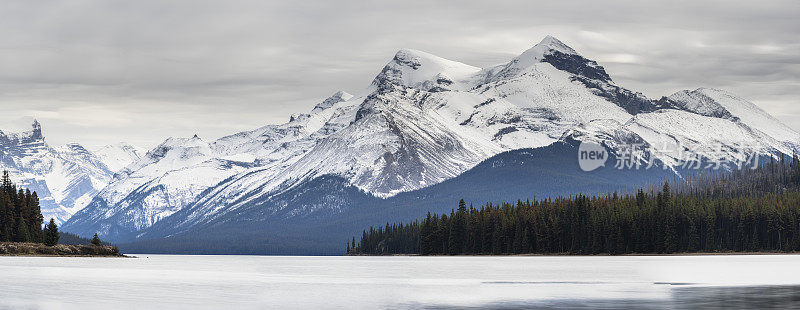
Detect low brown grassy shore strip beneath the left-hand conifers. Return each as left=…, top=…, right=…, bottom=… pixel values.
left=0, top=242, right=126, bottom=257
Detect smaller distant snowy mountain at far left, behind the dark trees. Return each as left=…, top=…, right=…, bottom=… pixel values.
left=0, top=117, right=144, bottom=223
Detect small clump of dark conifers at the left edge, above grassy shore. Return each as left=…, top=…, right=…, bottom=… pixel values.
left=0, top=171, right=52, bottom=242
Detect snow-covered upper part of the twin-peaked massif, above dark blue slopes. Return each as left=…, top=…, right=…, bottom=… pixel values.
left=65, top=36, right=800, bottom=240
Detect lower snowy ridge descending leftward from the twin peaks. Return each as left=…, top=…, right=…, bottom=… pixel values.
left=63, top=92, right=362, bottom=240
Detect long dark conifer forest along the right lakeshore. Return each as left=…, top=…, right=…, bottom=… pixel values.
left=347, top=156, right=800, bottom=255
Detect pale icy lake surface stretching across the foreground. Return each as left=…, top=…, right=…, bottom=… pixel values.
left=0, top=254, right=800, bottom=310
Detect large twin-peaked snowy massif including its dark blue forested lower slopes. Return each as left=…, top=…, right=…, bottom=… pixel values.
left=0, top=36, right=800, bottom=254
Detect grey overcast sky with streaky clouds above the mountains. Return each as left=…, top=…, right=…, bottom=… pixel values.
left=0, top=0, right=800, bottom=148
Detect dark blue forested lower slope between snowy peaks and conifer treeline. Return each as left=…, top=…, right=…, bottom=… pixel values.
left=121, top=140, right=674, bottom=255
